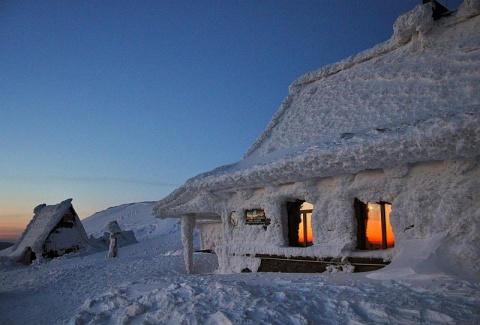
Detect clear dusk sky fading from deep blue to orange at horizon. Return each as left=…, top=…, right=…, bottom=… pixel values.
left=0, top=0, right=464, bottom=241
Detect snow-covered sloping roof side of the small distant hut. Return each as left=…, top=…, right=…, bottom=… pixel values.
left=12, top=199, right=83, bottom=255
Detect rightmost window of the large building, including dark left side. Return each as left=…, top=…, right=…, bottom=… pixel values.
left=355, top=199, right=395, bottom=250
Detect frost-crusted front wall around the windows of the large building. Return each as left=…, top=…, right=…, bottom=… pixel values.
left=208, top=157, right=480, bottom=272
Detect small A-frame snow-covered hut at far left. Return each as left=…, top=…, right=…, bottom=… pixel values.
left=10, top=199, right=89, bottom=264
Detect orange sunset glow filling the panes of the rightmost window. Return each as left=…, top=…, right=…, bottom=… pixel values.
left=367, top=203, right=395, bottom=247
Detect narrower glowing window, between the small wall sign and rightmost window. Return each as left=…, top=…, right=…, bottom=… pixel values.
left=287, top=200, right=313, bottom=247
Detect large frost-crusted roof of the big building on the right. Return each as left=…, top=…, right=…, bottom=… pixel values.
left=154, top=0, right=480, bottom=217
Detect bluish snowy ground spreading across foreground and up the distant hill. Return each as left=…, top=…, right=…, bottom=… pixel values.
left=0, top=203, right=480, bottom=324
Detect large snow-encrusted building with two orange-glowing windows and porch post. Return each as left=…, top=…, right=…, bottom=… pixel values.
left=154, top=0, right=480, bottom=274
